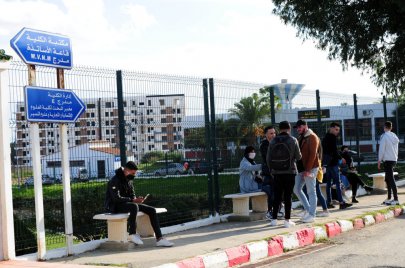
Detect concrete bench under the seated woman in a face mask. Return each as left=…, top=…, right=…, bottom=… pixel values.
left=224, top=192, right=267, bottom=219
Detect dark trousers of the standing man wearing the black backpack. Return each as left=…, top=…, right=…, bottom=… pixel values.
left=272, top=174, right=295, bottom=220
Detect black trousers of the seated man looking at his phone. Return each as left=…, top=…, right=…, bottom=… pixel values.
left=116, top=202, right=162, bottom=239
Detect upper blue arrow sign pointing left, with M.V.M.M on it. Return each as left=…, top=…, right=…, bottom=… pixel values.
left=10, top=28, right=73, bottom=69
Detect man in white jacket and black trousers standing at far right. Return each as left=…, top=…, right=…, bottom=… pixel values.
left=378, top=121, right=399, bottom=205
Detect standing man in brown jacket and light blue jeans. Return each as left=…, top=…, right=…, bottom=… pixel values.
left=294, top=120, right=322, bottom=223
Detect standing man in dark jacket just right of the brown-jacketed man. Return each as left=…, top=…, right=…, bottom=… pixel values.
left=322, top=122, right=352, bottom=209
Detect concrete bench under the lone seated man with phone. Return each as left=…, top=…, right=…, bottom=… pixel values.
left=93, top=208, right=167, bottom=243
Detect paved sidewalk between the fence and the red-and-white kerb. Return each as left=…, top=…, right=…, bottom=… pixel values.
left=0, top=187, right=405, bottom=268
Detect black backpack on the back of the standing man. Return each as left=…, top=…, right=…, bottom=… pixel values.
left=269, top=136, right=291, bottom=170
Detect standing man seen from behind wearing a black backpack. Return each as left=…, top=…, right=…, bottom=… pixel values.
left=266, top=121, right=301, bottom=228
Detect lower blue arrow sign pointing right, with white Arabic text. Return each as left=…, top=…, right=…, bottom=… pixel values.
left=25, top=86, right=86, bottom=123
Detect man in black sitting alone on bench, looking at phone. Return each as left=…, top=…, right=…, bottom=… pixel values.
left=105, top=161, right=174, bottom=247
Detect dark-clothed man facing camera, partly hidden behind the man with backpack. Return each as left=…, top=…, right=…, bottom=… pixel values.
left=260, top=126, right=276, bottom=220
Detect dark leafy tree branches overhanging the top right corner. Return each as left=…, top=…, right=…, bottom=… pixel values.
left=273, top=0, right=405, bottom=96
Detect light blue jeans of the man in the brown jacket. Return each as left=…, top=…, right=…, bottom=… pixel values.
left=294, top=167, right=318, bottom=217
